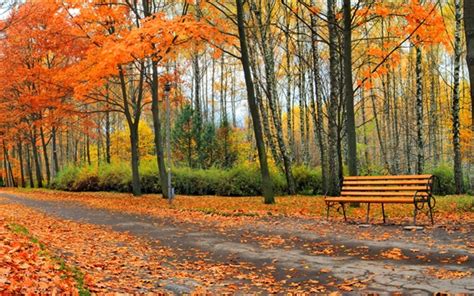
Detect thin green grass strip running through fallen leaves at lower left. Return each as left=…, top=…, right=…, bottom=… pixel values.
left=8, top=223, right=91, bottom=296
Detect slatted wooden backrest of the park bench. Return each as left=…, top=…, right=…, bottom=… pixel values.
left=341, top=175, right=433, bottom=197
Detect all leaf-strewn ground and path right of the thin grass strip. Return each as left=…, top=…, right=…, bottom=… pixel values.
left=0, top=190, right=474, bottom=294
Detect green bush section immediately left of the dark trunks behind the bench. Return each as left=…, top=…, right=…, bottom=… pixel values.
left=293, top=166, right=323, bottom=195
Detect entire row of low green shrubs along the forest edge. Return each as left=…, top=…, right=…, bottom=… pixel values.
left=51, top=161, right=464, bottom=196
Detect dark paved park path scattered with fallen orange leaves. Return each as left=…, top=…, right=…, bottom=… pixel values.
left=0, top=193, right=474, bottom=295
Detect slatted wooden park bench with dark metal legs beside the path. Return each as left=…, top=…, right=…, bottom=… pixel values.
left=324, top=175, right=436, bottom=225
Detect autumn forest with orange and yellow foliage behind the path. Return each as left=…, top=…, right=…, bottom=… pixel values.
left=0, top=0, right=474, bottom=203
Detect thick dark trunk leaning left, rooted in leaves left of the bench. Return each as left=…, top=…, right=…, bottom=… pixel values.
left=236, top=0, right=275, bottom=204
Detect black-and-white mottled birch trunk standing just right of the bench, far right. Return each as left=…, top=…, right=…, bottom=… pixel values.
left=452, top=0, right=467, bottom=194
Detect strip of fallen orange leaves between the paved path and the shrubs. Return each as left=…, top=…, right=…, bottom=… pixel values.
left=4, top=189, right=474, bottom=225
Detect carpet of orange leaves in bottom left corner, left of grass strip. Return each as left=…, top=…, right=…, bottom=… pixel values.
left=0, top=219, right=77, bottom=294
